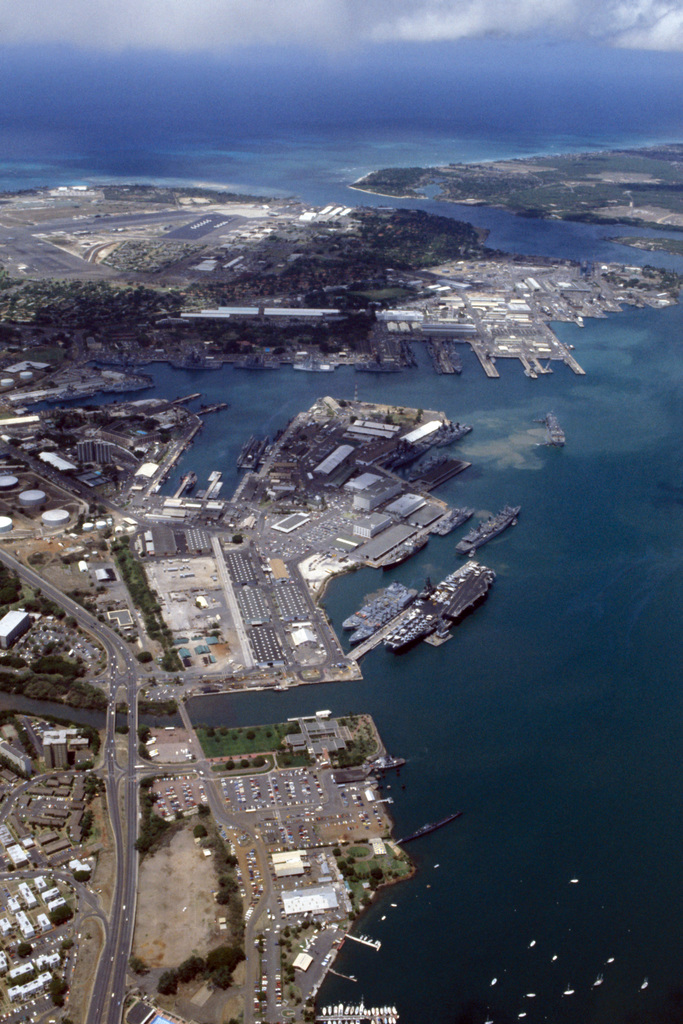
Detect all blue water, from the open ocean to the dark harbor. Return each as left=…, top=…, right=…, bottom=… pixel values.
left=7, top=34, right=683, bottom=1024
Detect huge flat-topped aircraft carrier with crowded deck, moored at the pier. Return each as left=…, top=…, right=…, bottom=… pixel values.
left=384, top=561, right=496, bottom=654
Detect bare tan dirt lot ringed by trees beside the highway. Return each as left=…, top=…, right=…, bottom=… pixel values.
left=133, top=822, right=220, bottom=968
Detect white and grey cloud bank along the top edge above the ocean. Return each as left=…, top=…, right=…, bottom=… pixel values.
left=0, top=0, right=683, bottom=52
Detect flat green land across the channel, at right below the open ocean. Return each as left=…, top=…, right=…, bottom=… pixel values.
left=353, top=144, right=683, bottom=227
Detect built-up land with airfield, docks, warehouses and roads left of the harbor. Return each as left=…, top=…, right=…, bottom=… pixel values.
left=0, top=178, right=680, bottom=1024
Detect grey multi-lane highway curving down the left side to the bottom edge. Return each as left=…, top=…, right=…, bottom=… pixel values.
left=0, top=551, right=138, bottom=1024
